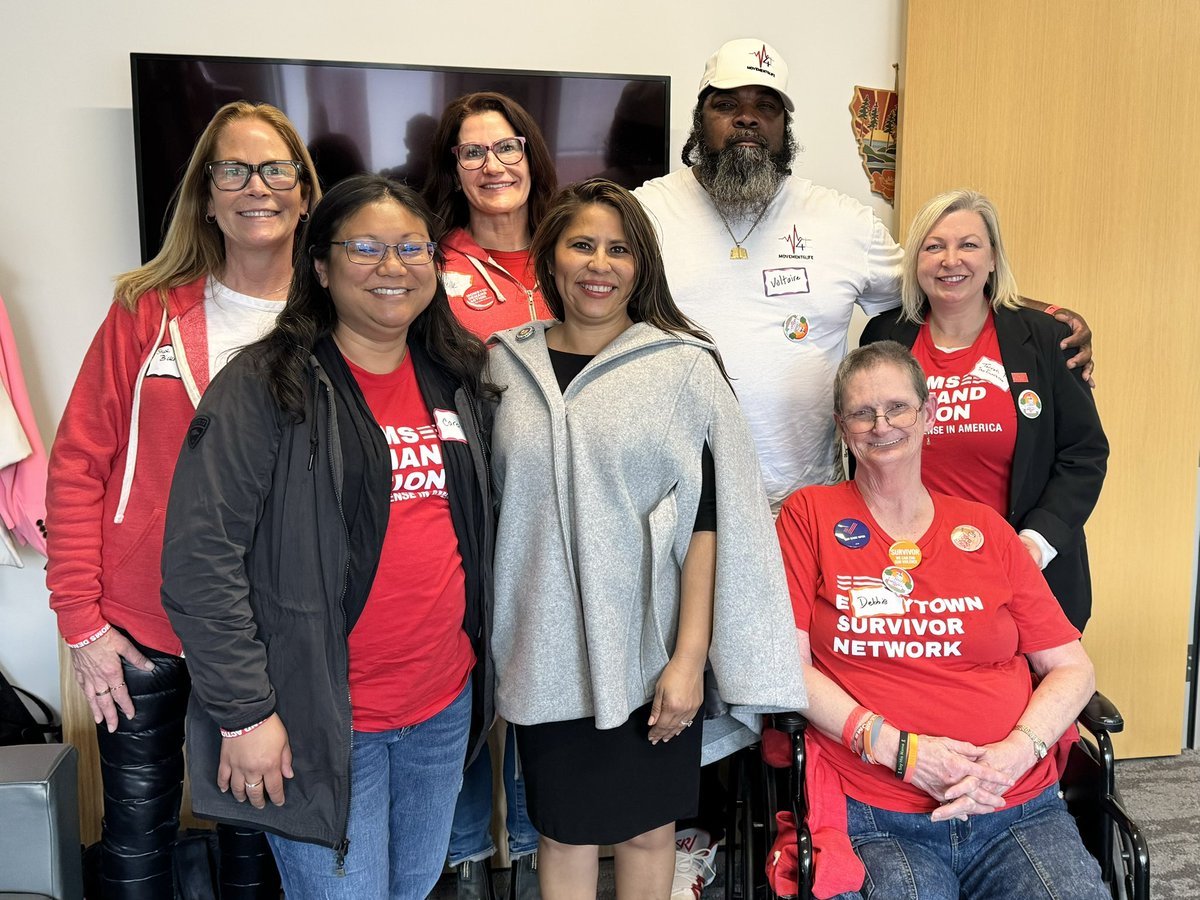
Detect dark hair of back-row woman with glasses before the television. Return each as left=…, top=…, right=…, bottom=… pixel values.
left=422, top=91, right=558, bottom=238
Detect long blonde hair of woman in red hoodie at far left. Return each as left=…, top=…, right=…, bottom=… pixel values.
left=114, top=100, right=320, bottom=311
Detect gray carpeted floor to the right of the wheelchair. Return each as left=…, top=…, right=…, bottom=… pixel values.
left=1117, top=750, right=1200, bottom=900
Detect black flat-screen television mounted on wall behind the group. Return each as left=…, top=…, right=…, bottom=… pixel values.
left=130, top=53, right=671, bottom=262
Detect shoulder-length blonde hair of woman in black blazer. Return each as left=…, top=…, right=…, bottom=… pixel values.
left=900, top=188, right=1021, bottom=323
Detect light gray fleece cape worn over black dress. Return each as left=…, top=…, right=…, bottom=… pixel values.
left=491, top=323, right=806, bottom=763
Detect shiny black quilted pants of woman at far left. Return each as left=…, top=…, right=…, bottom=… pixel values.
left=96, top=635, right=280, bottom=900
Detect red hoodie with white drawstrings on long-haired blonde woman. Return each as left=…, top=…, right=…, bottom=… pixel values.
left=46, top=277, right=209, bottom=655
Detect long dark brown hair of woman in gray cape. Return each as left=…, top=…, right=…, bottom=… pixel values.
left=529, top=178, right=730, bottom=380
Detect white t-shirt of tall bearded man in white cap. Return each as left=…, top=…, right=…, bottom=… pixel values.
left=634, top=169, right=902, bottom=511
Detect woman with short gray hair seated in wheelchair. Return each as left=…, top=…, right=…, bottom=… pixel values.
left=778, top=341, right=1109, bottom=900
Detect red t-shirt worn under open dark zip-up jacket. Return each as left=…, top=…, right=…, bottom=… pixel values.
left=347, top=355, right=475, bottom=732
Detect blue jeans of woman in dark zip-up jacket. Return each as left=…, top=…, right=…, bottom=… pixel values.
left=268, top=680, right=470, bottom=900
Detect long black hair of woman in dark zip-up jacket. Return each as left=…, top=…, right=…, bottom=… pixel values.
left=250, top=175, right=491, bottom=418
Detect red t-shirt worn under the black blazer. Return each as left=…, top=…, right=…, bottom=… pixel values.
left=912, top=316, right=1016, bottom=516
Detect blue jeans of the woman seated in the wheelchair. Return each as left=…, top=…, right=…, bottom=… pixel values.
left=840, top=785, right=1111, bottom=900
